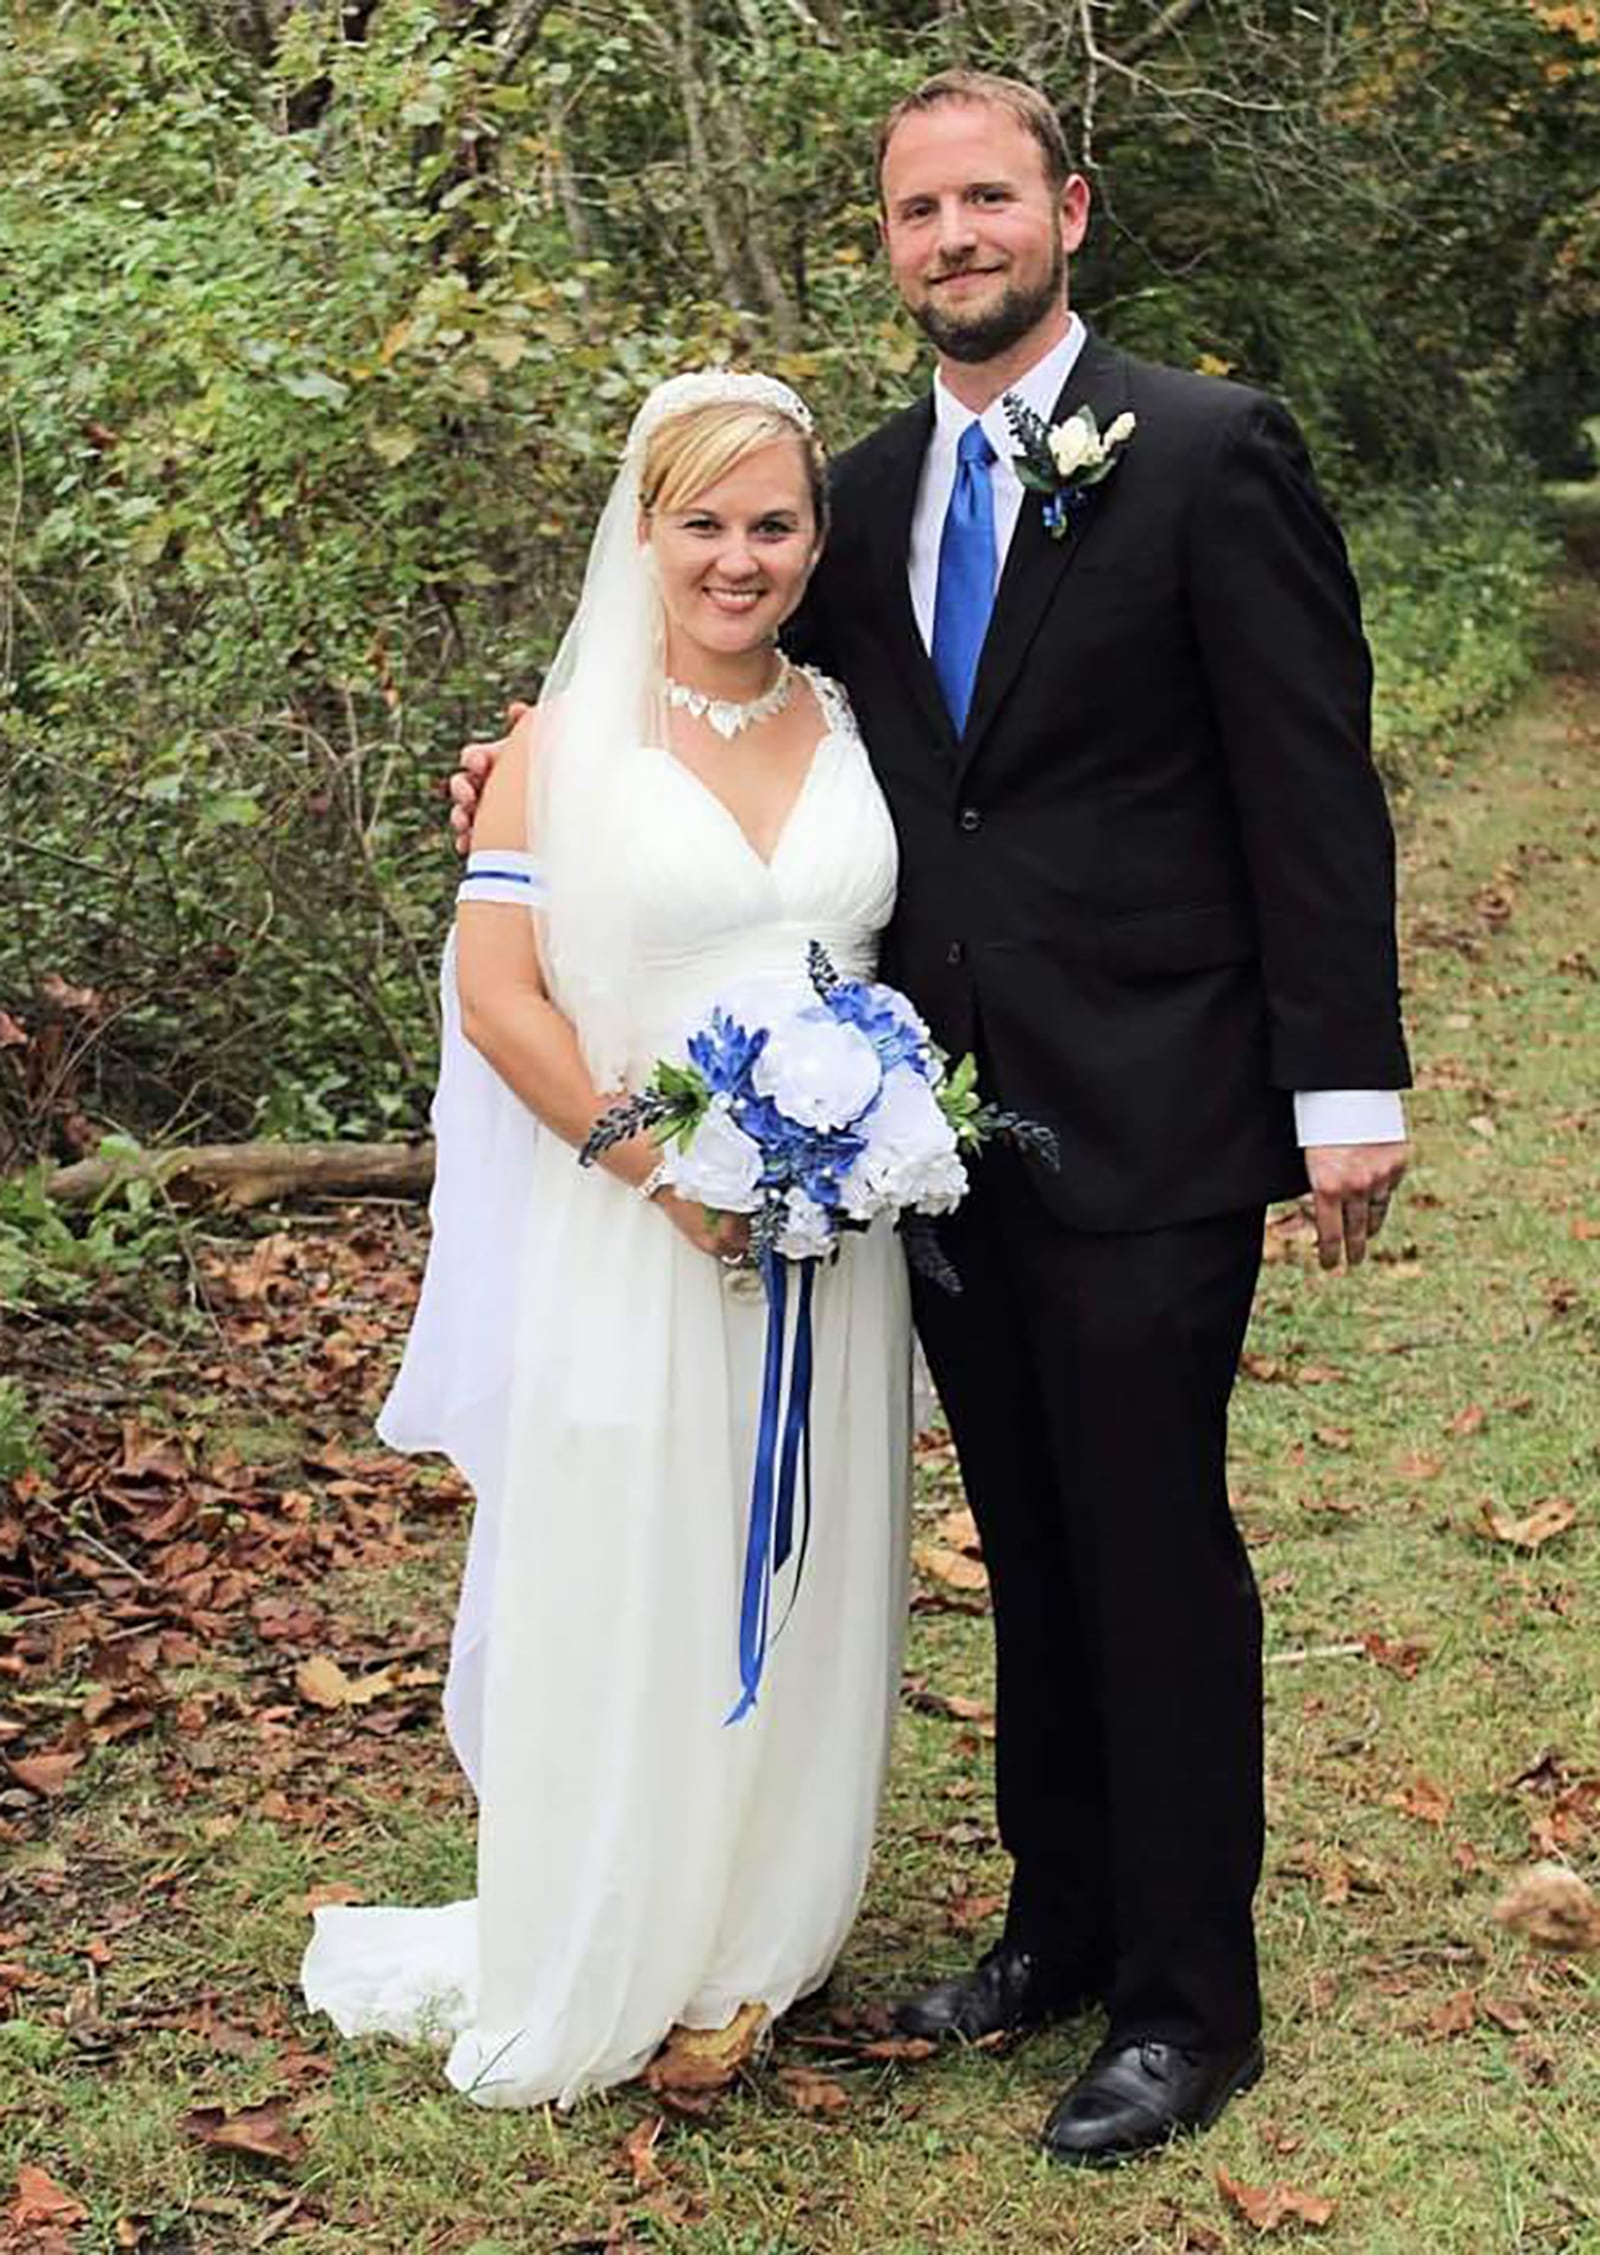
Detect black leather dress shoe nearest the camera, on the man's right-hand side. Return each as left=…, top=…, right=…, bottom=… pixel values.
left=1043, top=2036, right=1266, bottom=2167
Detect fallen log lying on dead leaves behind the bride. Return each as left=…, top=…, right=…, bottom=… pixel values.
left=45, top=1141, right=433, bottom=1206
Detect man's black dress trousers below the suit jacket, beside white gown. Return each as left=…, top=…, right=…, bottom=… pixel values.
left=915, top=1152, right=1262, bottom=2048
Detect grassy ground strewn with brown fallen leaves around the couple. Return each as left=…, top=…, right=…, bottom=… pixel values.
left=0, top=536, right=1600, bottom=2255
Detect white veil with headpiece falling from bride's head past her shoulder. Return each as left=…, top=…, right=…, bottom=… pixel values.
left=527, top=368, right=811, bottom=1089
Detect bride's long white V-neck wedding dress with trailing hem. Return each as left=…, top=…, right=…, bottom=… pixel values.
left=302, top=686, right=910, bottom=2106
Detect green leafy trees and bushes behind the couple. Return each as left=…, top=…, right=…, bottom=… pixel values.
left=0, top=0, right=1600, bottom=1164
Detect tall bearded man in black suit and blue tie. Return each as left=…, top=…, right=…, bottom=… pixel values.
left=455, top=72, right=1408, bottom=2163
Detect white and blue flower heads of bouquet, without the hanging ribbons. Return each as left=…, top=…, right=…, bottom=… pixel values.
left=584, top=943, right=1055, bottom=1290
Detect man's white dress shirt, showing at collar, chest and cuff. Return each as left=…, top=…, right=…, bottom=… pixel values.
left=906, top=313, right=1406, bottom=1148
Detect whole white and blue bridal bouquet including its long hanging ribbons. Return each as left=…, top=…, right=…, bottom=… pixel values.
left=579, top=943, right=1055, bottom=1723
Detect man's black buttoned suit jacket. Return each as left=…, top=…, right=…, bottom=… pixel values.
left=793, top=334, right=1408, bottom=1229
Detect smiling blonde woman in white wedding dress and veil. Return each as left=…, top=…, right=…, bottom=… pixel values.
left=302, top=370, right=910, bottom=2106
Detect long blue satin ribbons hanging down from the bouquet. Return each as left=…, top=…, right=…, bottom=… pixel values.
left=728, top=1254, right=816, bottom=1723
